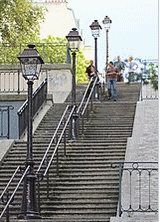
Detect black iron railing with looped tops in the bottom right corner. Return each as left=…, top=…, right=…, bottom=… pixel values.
left=111, top=161, right=158, bottom=217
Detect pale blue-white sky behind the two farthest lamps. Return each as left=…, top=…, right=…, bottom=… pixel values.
left=68, top=0, right=158, bottom=71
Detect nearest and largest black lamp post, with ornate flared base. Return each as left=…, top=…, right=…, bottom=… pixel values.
left=17, top=44, right=44, bottom=219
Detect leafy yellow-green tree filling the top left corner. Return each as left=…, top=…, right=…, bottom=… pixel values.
left=0, top=0, right=44, bottom=45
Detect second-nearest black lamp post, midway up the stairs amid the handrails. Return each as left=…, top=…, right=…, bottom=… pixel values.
left=66, top=28, right=82, bottom=140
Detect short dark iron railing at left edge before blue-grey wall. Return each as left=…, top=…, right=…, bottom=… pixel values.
left=0, top=105, right=14, bottom=139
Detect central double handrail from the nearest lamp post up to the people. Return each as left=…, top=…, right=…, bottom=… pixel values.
left=36, top=77, right=98, bottom=206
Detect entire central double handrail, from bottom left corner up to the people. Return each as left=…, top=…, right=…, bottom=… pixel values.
left=0, top=77, right=98, bottom=222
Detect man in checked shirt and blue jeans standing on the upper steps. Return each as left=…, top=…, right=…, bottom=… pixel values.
left=106, top=62, right=120, bottom=101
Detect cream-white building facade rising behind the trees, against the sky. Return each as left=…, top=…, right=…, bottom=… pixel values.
left=36, top=0, right=93, bottom=60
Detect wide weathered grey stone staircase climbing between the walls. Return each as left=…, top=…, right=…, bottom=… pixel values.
left=0, top=83, right=139, bottom=222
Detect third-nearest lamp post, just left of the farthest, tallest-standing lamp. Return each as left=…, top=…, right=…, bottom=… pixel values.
left=89, top=20, right=102, bottom=100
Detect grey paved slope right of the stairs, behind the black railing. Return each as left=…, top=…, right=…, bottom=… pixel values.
left=110, top=84, right=159, bottom=222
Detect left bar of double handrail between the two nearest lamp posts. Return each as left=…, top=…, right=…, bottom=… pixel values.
left=36, top=105, right=69, bottom=174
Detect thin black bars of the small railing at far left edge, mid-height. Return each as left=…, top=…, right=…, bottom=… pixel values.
left=0, top=105, right=14, bottom=139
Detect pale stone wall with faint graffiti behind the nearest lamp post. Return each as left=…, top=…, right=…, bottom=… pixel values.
left=0, top=64, right=72, bottom=103
